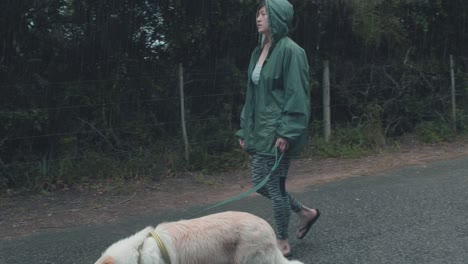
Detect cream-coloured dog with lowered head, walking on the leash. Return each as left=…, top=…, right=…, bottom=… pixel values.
left=95, top=212, right=303, bottom=264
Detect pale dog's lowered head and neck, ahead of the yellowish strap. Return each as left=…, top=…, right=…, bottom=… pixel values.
left=95, top=227, right=153, bottom=264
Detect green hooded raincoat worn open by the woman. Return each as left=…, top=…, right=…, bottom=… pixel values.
left=236, top=0, right=310, bottom=157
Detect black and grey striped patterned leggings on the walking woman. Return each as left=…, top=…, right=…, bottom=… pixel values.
left=251, top=154, right=302, bottom=240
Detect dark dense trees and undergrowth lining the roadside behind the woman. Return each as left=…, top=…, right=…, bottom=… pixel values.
left=0, top=0, right=468, bottom=191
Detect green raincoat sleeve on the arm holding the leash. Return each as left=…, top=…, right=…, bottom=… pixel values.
left=277, top=48, right=310, bottom=143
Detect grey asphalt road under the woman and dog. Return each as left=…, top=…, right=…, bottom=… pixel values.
left=0, top=157, right=468, bottom=264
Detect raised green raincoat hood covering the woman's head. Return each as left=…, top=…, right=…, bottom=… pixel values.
left=260, top=0, right=294, bottom=43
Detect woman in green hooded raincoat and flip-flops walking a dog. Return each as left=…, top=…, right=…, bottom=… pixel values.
left=236, top=0, right=320, bottom=256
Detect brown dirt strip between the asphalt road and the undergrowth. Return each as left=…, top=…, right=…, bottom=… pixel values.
left=0, top=140, right=468, bottom=239
